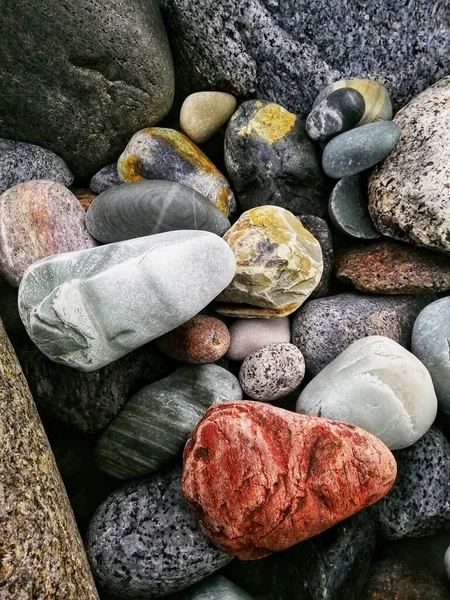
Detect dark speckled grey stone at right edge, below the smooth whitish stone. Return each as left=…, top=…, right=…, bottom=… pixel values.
left=371, top=427, right=450, bottom=539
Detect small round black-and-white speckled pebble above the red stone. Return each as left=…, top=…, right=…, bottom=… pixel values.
left=239, top=343, right=305, bottom=402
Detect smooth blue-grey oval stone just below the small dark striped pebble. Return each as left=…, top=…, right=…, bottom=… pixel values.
left=322, top=121, right=401, bottom=179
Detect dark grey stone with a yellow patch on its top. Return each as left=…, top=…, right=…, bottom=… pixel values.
left=225, top=100, right=329, bottom=216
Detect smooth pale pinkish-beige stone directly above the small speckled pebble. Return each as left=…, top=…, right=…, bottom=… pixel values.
left=226, top=317, right=291, bottom=361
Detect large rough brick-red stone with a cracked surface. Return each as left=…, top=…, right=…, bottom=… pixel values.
left=182, top=401, right=396, bottom=560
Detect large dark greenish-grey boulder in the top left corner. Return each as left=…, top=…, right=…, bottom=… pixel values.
left=0, top=0, right=174, bottom=178
